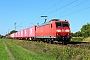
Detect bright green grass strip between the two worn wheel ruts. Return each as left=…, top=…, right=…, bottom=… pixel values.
left=5, top=40, right=41, bottom=60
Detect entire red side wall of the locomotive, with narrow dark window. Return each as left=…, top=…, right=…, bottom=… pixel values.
left=36, top=23, right=55, bottom=38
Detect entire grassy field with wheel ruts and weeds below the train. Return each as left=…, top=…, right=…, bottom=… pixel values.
left=0, top=39, right=90, bottom=60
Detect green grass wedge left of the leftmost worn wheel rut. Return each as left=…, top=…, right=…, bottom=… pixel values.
left=0, top=39, right=9, bottom=60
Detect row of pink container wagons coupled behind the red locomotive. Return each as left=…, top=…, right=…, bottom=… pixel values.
left=10, top=26, right=36, bottom=40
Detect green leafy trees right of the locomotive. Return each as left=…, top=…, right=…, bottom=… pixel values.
left=71, top=23, right=90, bottom=37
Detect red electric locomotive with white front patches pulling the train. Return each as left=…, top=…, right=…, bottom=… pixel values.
left=36, top=19, right=71, bottom=43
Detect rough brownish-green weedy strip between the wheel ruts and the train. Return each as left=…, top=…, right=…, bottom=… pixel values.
left=13, top=41, right=90, bottom=60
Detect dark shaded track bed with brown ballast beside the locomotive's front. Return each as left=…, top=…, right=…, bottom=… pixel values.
left=50, top=42, right=90, bottom=49
